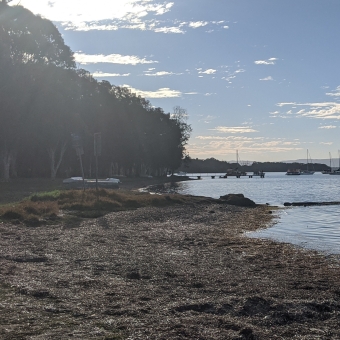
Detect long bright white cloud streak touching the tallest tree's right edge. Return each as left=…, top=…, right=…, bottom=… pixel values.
left=74, top=53, right=158, bottom=65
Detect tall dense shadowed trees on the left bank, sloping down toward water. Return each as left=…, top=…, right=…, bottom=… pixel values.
left=0, top=0, right=191, bottom=180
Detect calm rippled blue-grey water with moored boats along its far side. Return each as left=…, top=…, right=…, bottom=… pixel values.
left=157, top=173, right=340, bottom=254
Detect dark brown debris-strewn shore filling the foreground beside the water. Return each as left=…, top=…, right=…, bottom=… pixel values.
left=0, top=198, right=340, bottom=340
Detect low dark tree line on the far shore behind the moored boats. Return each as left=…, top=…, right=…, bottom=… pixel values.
left=179, top=158, right=330, bottom=173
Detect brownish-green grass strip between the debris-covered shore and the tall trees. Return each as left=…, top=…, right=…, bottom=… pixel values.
left=0, top=189, right=191, bottom=225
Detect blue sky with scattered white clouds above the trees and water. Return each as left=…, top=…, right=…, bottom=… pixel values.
left=10, top=0, right=340, bottom=161
